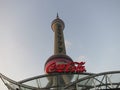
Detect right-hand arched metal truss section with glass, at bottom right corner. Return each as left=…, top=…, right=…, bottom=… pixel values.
left=65, top=71, right=120, bottom=90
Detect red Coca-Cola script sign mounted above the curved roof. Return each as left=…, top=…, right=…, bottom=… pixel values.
left=46, top=62, right=86, bottom=73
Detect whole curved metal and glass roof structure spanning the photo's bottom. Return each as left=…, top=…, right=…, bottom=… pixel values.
left=0, top=71, right=120, bottom=90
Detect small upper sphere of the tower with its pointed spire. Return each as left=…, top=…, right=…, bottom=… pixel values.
left=51, top=14, right=65, bottom=31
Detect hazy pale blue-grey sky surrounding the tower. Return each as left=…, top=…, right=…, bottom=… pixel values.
left=0, top=0, right=120, bottom=90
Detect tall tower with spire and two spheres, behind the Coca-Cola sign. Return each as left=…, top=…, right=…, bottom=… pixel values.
left=45, top=14, right=73, bottom=90
